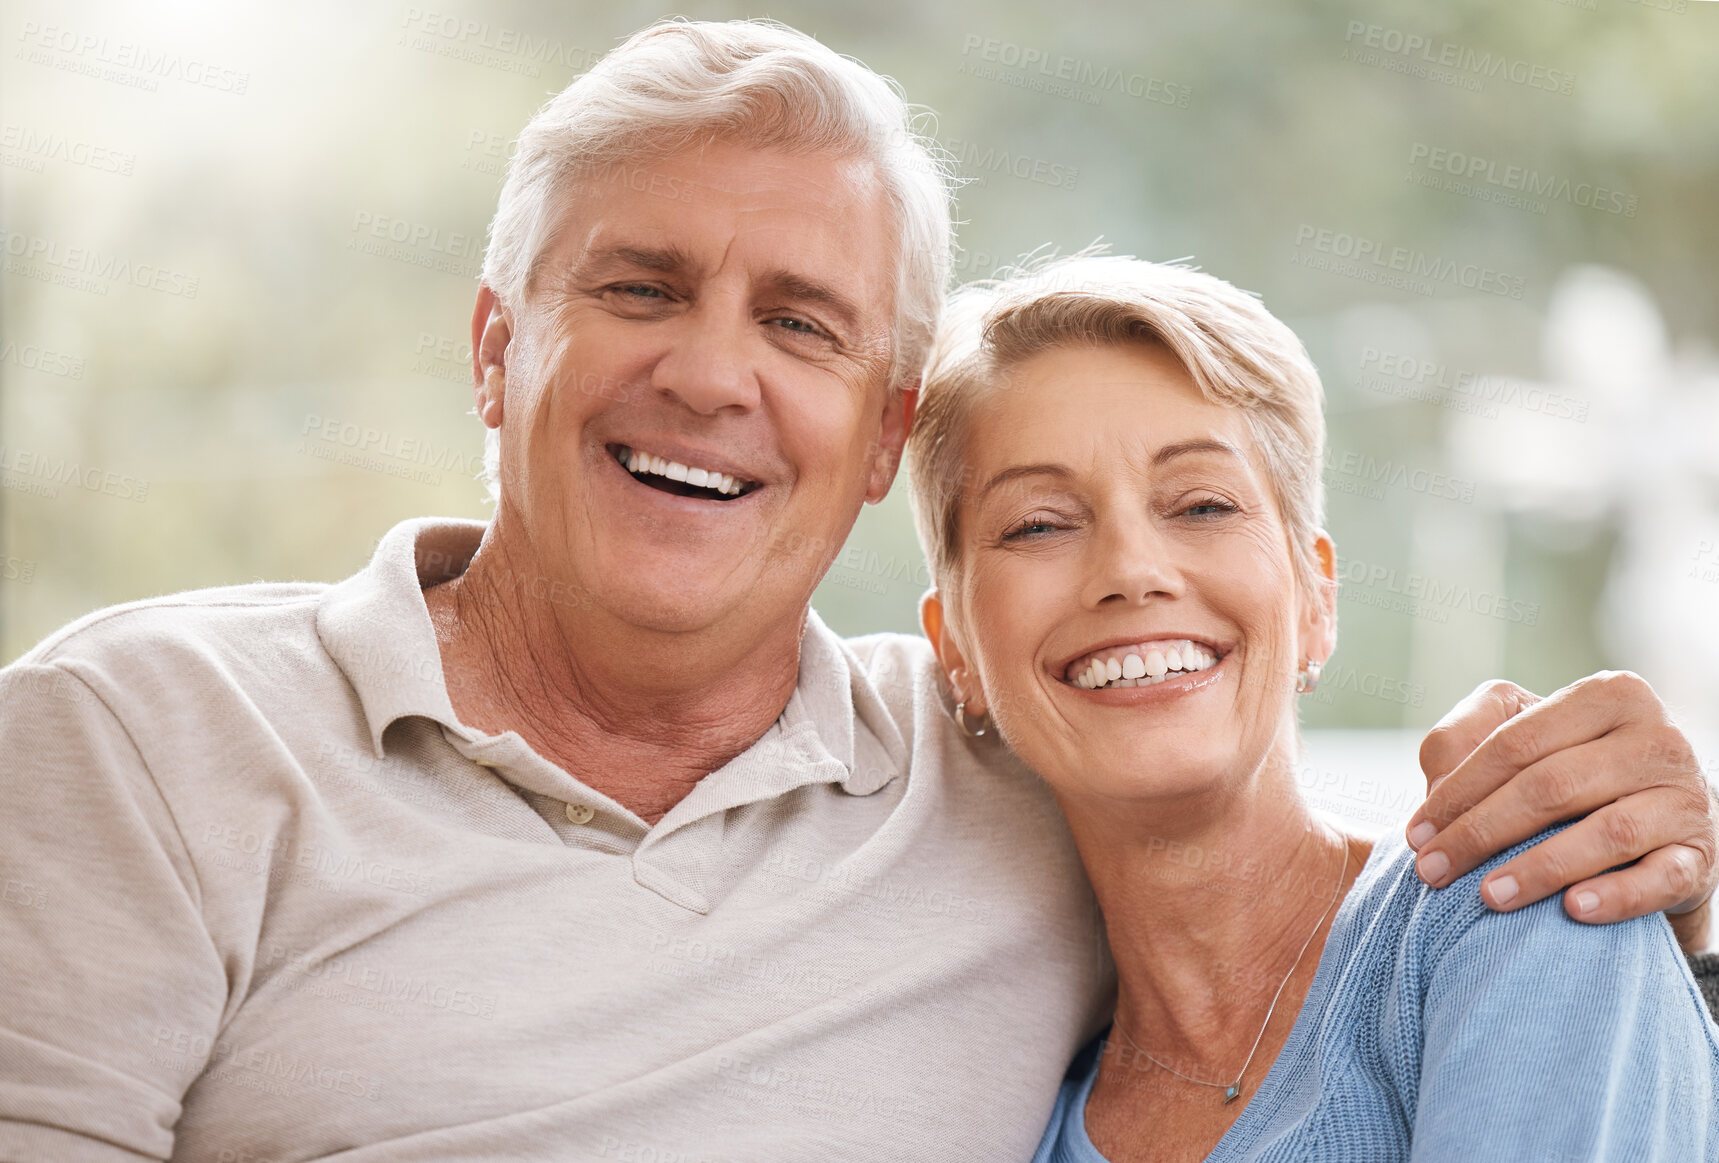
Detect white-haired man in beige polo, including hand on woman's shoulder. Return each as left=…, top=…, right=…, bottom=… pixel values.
left=0, top=24, right=1716, bottom=1163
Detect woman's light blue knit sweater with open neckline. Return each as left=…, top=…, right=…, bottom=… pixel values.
left=1033, top=821, right=1719, bottom=1163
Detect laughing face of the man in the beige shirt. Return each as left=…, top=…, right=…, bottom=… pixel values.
left=474, top=143, right=904, bottom=632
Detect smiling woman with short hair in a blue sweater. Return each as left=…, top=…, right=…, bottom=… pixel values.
left=913, top=256, right=1719, bottom=1163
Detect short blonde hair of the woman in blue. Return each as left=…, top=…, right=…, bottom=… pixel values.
left=908, top=253, right=1325, bottom=594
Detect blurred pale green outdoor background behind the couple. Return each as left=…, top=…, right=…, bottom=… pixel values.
left=0, top=0, right=1719, bottom=727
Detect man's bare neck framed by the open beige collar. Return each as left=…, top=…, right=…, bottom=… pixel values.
left=425, top=529, right=804, bottom=825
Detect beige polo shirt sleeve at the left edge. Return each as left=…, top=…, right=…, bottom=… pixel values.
left=0, top=663, right=227, bottom=1163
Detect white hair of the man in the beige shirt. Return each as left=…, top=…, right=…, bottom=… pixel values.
left=483, top=19, right=954, bottom=500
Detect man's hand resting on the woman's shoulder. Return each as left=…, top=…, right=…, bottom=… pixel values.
left=1408, top=670, right=1719, bottom=952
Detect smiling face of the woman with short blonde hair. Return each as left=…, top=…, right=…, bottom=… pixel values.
left=944, top=334, right=1332, bottom=799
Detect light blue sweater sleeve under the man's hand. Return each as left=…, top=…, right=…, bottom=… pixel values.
left=1411, top=873, right=1719, bottom=1163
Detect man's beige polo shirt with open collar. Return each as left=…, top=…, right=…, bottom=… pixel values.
left=0, top=519, right=1112, bottom=1163
